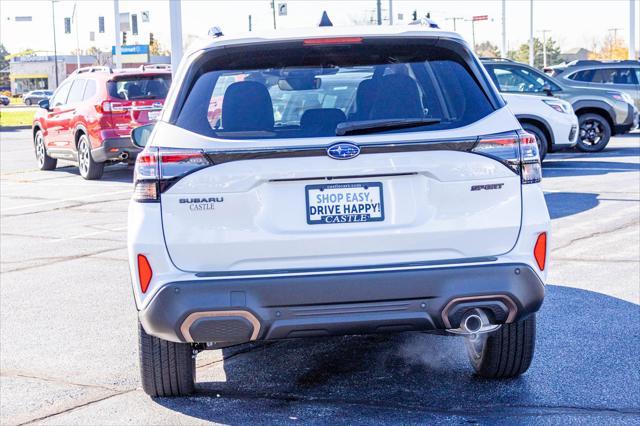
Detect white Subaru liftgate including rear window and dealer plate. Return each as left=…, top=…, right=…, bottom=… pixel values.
left=153, top=36, right=521, bottom=272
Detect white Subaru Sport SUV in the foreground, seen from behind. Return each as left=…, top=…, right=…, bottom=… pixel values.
left=128, top=26, right=550, bottom=396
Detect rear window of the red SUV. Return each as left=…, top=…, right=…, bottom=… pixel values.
left=107, top=74, right=171, bottom=101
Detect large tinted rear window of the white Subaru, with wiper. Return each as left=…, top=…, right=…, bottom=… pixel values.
left=175, top=39, right=495, bottom=139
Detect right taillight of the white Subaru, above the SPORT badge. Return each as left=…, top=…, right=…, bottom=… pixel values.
left=473, top=131, right=542, bottom=184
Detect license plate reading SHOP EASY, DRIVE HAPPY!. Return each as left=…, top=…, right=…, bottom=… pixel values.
left=305, top=182, right=384, bottom=225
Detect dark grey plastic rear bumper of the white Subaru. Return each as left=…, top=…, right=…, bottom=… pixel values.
left=139, top=263, right=544, bottom=344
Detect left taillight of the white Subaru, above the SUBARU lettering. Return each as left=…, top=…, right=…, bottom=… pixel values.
left=133, top=148, right=212, bottom=203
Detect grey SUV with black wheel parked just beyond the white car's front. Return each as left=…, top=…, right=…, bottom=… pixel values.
left=482, top=59, right=638, bottom=152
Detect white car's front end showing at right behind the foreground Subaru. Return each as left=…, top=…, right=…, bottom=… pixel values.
left=502, top=93, right=578, bottom=160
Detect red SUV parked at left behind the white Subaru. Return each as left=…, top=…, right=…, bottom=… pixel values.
left=33, top=66, right=171, bottom=179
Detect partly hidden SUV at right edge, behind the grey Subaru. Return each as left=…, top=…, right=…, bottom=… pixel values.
left=552, top=60, right=640, bottom=109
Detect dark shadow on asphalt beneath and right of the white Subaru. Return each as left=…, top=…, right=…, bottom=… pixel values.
left=156, top=286, right=640, bottom=424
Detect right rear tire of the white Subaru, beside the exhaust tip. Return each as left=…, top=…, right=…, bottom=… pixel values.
left=466, top=314, right=536, bottom=379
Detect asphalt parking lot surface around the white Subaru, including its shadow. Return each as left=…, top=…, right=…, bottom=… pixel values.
left=0, top=130, right=640, bottom=425
